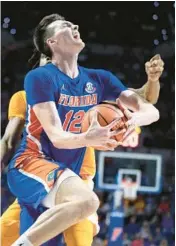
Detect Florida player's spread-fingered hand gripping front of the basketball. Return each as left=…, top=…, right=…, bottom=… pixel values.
left=85, top=111, right=126, bottom=150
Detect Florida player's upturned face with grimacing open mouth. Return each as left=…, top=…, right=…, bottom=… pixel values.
left=47, top=20, right=85, bottom=54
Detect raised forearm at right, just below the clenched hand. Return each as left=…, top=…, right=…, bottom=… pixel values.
left=144, top=80, right=160, bottom=104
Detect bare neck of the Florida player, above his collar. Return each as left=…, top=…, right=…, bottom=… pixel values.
left=52, top=54, right=79, bottom=79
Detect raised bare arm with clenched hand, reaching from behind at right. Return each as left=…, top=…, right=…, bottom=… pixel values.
left=130, top=55, right=164, bottom=104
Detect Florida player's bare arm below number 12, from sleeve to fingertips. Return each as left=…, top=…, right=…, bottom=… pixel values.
left=33, top=102, right=124, bottom=150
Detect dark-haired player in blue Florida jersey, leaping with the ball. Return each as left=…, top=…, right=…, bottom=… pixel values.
left=8, top=14, right=159, bottom=246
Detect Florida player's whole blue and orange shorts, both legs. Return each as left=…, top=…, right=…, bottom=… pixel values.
left=7, top=157, right=64, bottom=246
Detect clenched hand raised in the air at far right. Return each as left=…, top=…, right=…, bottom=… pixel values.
left=145, top=55, right=164, bottom=82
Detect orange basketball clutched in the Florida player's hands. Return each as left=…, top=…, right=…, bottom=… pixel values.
left=81, top=102, right=127, bottom=150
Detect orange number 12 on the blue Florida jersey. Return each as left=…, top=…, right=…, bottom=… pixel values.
left=63, top=110, right=85, bottom=133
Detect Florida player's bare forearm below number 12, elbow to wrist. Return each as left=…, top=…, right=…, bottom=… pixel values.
left=49, top=128, right=87, bottom=149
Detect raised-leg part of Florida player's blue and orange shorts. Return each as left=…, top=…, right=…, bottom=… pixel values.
left=7, top=157, right=63, bottom=209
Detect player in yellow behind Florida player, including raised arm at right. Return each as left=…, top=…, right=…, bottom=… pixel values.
left=0, top=50, right=163, bottom=246
